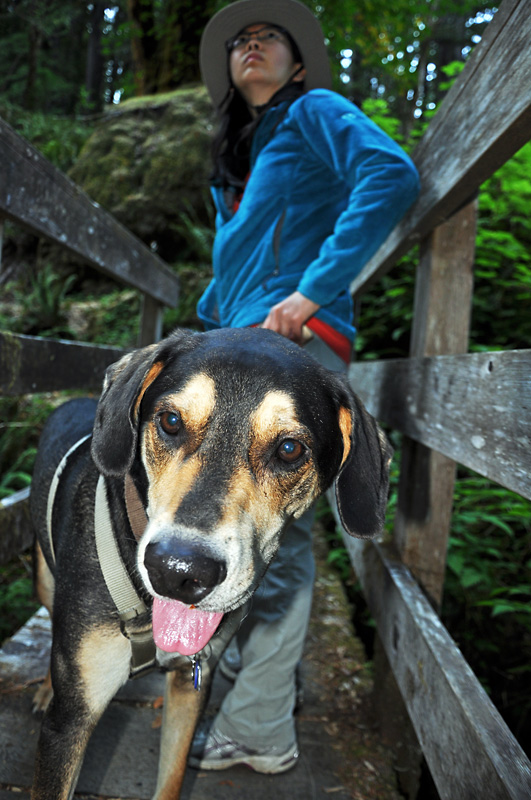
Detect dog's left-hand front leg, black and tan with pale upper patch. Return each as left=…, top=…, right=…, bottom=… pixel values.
left=31, top=626, right=131, bottom=800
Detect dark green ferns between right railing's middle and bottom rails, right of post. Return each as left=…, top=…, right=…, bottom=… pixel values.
left=443, top=470, right=531, bottom=748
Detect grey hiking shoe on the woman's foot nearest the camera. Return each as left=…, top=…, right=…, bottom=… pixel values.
left=188, top=728, right=299, bottom=774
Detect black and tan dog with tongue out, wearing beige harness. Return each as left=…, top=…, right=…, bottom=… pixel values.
left=31, top=329, right=391, bottom=800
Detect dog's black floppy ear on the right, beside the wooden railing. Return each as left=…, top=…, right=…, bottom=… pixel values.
left=335, top=390, right=393, bottom=539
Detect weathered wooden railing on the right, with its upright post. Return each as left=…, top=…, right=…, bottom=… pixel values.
left=336, top=0, right=531, bottom=800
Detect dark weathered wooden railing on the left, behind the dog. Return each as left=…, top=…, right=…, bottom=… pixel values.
left=0, top=109, right=179, bottom=564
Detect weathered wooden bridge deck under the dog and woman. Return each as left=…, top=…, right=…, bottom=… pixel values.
left=0, top=532, right=399, bottom=800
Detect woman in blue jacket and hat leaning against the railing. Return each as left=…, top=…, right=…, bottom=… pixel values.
left=190, top=0, right=418, bottom=772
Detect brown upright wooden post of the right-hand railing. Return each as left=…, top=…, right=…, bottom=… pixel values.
left=393, top=202, right=477, bottom=608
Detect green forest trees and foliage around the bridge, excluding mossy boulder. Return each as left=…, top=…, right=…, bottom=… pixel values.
left=0, top=0, right=531, bottom=764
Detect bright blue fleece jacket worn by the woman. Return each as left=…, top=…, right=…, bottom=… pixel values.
left=197, top=89, right=419, bottom=339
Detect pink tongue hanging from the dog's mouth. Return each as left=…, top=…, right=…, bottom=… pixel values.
left=153, top=597, right=223, bottom=656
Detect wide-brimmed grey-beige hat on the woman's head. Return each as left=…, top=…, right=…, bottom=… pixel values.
left=199, top=0, right=332, bottom=108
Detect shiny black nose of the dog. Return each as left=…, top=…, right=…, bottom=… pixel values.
left=144, top=538, right=227, bottom=605
